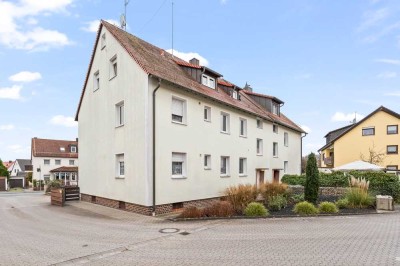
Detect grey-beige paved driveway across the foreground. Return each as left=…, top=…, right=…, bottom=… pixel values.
left=0, top=193, right=400, bottom=265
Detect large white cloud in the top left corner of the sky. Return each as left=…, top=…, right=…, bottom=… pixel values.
left=0, top=0, right=73, bottom=51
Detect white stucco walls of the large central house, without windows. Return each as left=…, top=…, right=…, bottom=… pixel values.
left=78, top=27, right=301, bottom=206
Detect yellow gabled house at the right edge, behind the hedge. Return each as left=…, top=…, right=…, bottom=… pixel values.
left=318, top=106, right=400, bottom=171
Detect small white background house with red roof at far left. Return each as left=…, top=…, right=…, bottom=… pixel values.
left=31, top=138, right=78, bottom=185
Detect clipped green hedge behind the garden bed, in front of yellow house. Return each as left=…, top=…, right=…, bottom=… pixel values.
left=282, top=171, right=400, bottom=202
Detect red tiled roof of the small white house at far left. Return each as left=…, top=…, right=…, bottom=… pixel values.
left=32, top=138, right=78, bottom=158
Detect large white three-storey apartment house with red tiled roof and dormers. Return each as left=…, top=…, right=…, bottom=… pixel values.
left=75, top=21, right=304, bottom=215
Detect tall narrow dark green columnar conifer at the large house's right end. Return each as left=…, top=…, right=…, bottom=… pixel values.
left=304, top=153, right=319, bottom=203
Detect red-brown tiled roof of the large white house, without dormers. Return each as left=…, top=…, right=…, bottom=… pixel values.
left=75, top=20, right=303, bottom=132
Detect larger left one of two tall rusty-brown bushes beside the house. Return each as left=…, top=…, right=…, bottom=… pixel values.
left=225, top=184, right=258, bottom=214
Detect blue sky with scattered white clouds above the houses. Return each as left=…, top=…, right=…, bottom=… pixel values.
left=0, top=0, right=400, bottom=160
